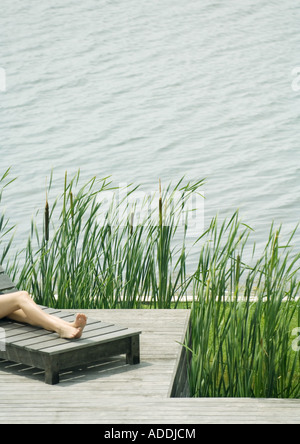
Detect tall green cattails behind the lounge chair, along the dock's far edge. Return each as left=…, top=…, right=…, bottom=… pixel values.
left=16, top=171, right=202, bottom=308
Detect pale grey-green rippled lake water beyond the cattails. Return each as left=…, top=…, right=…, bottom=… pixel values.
left=0, top=0, right=300, bottom=264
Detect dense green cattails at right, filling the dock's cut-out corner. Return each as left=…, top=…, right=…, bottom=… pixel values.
left=188, top=214, right=300, bottom=398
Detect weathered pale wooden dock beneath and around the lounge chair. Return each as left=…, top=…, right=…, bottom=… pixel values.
left=0, top=310, right=300, bottom=424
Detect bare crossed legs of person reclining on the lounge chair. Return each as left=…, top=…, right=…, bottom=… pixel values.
left=0, top=291, right=86, bottom=339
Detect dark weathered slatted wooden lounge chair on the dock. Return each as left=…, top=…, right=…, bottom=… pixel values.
left=0, top=266, right=141, bottom=384
